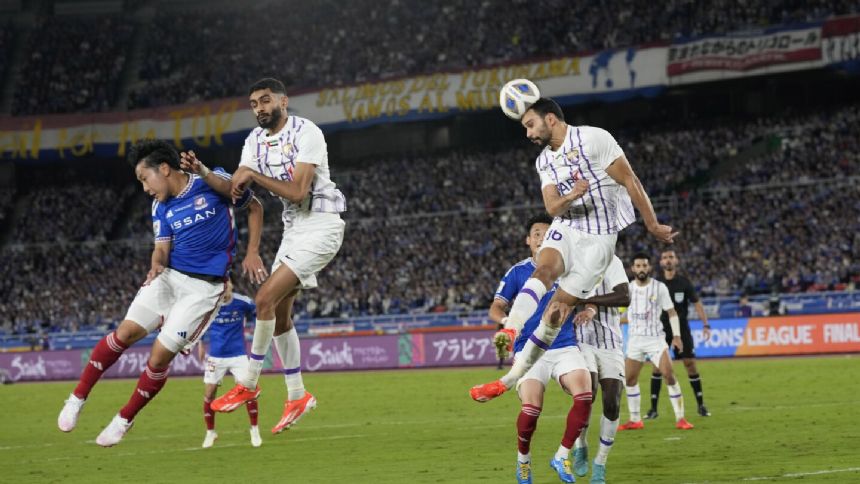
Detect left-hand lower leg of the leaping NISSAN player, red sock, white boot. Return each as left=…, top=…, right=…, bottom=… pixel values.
left=57, top=328, right=134, bottom=432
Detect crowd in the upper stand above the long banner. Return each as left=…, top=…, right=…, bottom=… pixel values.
left=0, top=0, right=860, bottom=115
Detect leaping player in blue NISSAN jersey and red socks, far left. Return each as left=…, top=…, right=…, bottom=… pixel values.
left=57, top=140, right=263, bottom=447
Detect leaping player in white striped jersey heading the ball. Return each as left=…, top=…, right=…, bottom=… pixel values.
left=471, top=98, right=675, bottom=401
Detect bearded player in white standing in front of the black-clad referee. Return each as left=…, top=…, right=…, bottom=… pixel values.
left=619, top=254, right=693, bottom=430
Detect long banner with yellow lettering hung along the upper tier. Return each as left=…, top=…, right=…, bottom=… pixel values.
left=0, top=47, right=667, bottom=161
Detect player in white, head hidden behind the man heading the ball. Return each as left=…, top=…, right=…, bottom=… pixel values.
left=573, top=256, right=630, bottom=482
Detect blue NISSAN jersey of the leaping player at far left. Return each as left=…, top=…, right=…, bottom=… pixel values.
left=152, top=168, right=253, bottom=277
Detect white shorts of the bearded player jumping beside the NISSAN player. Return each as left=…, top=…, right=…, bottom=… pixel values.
left=272, top=212, right=346, bottom=289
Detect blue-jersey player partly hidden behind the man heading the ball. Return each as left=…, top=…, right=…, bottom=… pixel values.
left=484, top=215, right=591, bottom=483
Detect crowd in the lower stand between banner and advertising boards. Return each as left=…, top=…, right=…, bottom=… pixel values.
left=0, top=101, right=860, bottom=331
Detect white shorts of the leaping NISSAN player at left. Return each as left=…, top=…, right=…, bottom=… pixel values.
left=125, top=268, right=226, bottom=353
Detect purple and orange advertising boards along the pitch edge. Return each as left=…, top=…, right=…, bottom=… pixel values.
left=0, top=313, right=860, bottom=381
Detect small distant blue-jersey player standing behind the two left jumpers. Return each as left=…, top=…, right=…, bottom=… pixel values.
left=198, top=280, right=263, bottom=449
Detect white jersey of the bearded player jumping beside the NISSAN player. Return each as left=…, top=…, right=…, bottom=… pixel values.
left=239, top=115, right=346, bottom=228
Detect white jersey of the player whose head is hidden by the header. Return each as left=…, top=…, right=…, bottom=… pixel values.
left=576, top=256, right=627, bottom=351
